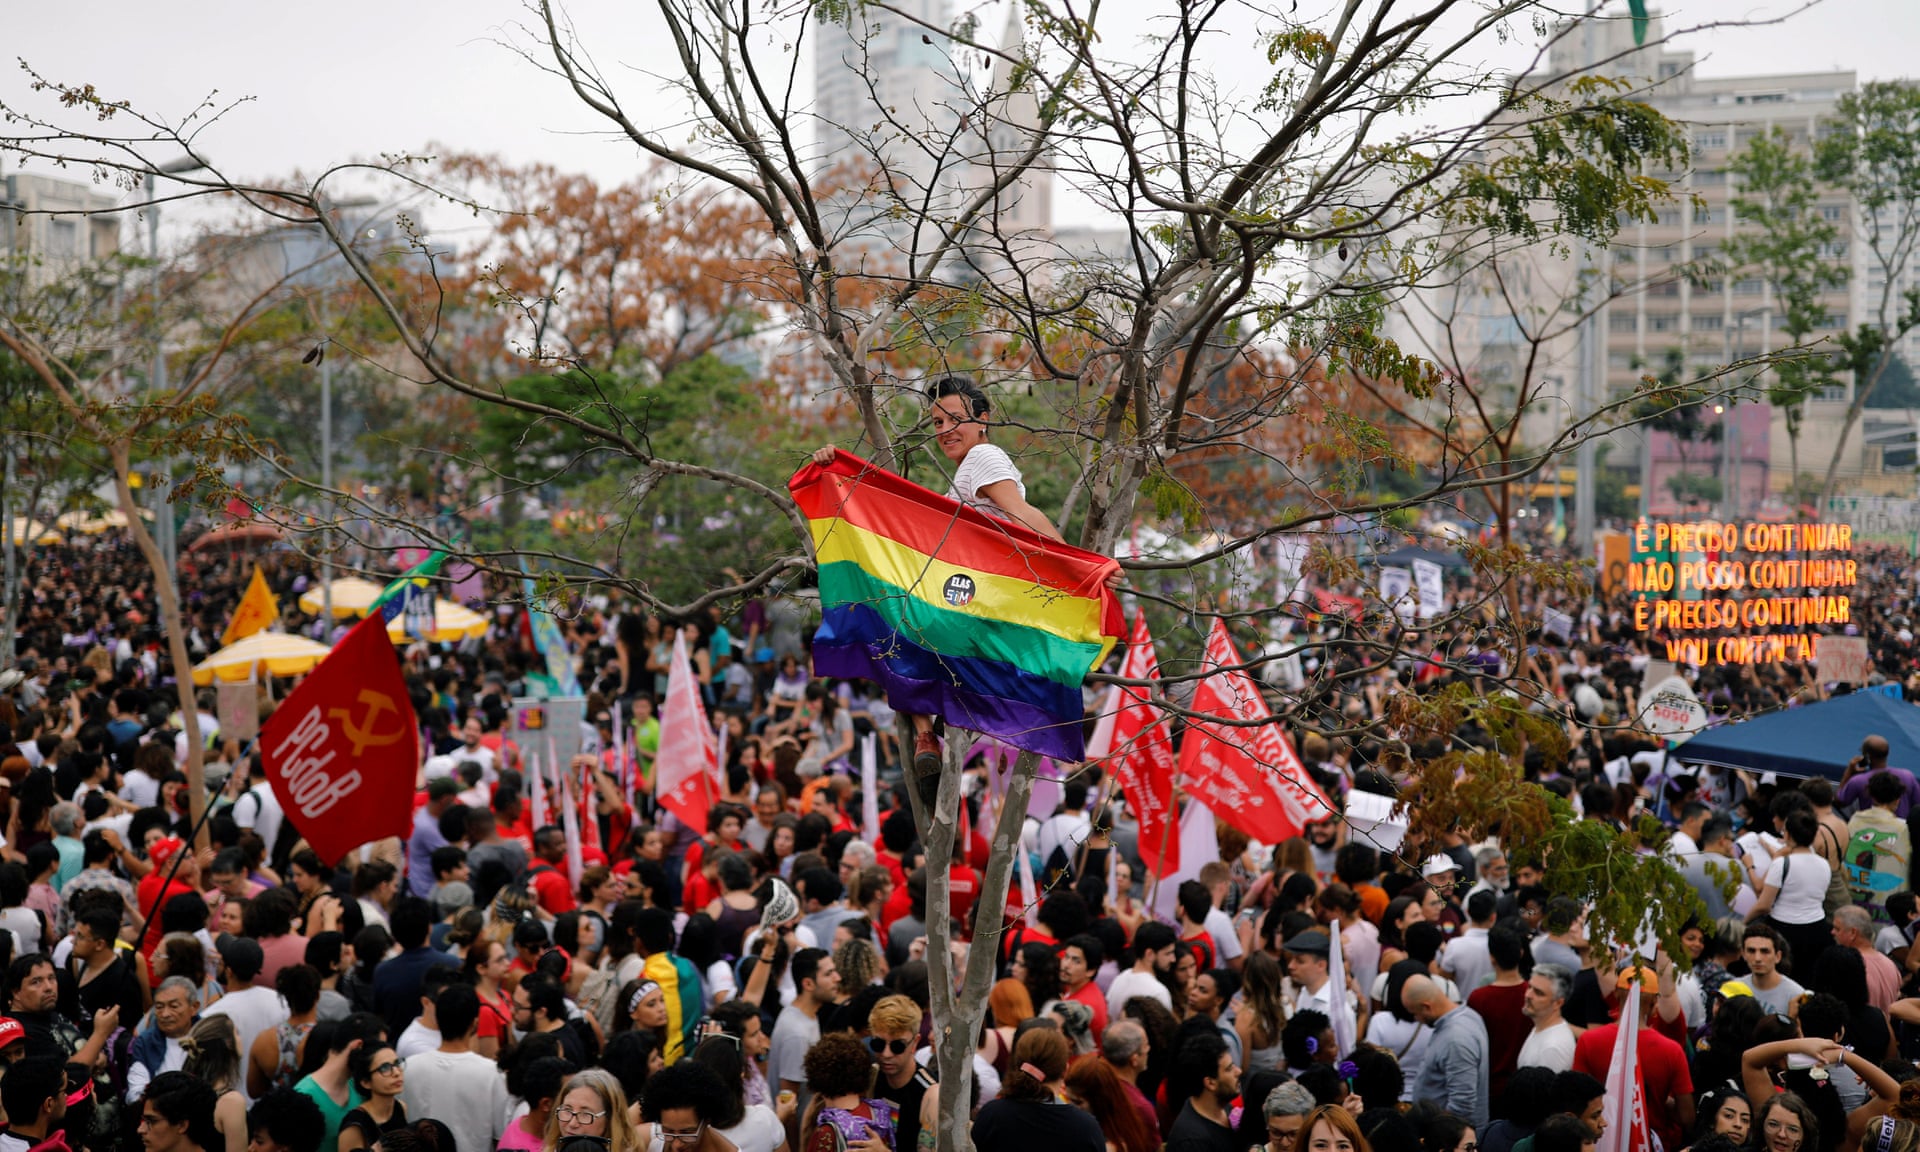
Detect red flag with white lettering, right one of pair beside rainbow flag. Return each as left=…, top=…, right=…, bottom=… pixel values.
left=1181, top=620, right=1334, bottom=845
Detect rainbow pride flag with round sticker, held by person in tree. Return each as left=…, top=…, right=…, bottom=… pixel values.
left=787, top=451, right=1127, bottom=760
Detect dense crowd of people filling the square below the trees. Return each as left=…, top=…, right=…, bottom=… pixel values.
left=0, top=489, right=1920, bottom=1152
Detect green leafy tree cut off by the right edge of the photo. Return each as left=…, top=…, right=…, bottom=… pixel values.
left=1816, top=81, right=1920, bottom=507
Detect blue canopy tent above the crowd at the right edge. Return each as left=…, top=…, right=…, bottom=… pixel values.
left=1672, top=691, right=1920, bottom=783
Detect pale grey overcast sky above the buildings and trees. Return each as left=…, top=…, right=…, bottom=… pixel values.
left=0, top=0, right=1920, bottom=231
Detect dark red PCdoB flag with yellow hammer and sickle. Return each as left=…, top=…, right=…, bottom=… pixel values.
left=259, top=612, right=420, bottom=864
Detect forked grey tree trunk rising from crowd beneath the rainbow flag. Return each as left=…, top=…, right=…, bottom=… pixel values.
left=906, top=730, right=1039, bottom=1152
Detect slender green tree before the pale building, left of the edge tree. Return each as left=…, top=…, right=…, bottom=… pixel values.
left=1726, top=129, right=1847, bottom=487
